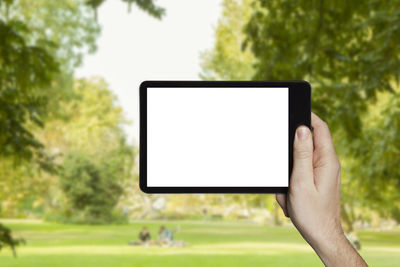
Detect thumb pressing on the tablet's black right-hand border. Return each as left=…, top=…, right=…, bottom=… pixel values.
left=291, top=126, right=314, bottom=187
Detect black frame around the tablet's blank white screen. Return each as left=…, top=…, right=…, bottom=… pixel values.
left=139, top=81, right=311, bottom=194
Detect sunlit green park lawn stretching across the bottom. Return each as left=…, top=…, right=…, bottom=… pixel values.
left=0, top=220, right=400, bottom=267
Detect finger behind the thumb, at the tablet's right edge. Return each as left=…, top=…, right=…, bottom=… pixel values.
left=311, top=113, right=336, bottom=161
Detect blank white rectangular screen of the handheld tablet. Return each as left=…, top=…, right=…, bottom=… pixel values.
left=147, top=87, right=289, bottom=187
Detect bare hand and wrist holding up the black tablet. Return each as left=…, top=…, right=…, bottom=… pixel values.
left=276, top=114, right=368, bottom=267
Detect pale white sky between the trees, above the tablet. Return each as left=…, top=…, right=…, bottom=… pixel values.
left=76, top=0, right=222, bottom=144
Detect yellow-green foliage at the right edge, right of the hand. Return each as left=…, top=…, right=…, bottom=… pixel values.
left=352, top=91, right=400, bottom=222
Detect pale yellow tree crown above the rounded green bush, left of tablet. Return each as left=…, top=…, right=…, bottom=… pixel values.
left=36, top=77, right=128, bottom=153
